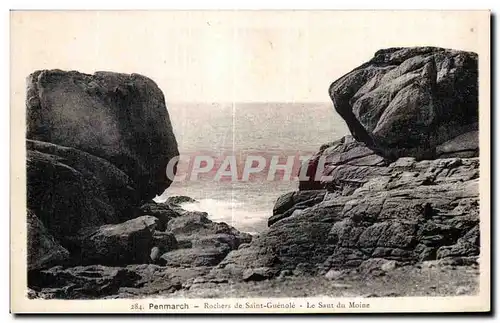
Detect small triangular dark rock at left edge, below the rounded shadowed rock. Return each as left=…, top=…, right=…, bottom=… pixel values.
left=27, top=210, right=69, bottom=271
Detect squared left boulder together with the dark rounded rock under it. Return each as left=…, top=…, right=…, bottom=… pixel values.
left=26, top=70, right=179, bottom=268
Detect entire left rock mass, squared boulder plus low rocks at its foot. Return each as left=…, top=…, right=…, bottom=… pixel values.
left=26, top=70, right=251, bottom=298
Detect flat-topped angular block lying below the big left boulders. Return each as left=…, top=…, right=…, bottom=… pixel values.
left=78, top=216, right=158, bottom=266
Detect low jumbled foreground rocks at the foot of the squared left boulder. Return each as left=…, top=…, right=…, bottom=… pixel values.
left=28, top=197, right=252, bottom=299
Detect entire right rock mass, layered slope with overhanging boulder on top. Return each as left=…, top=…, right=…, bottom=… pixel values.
left=218, top=47, right=480, bottom=290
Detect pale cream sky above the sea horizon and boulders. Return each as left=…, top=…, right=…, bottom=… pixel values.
left=11, top=11, right=484, bottom=102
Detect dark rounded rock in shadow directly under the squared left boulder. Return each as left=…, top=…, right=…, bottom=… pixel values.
left=26, top=140, right=133, bottom=243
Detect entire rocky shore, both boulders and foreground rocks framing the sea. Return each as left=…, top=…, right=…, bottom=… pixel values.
left=27, top=47, right=480, bottom=299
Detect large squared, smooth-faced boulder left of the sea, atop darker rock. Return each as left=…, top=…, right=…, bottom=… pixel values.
left=26, top=70, right=179, bottom=203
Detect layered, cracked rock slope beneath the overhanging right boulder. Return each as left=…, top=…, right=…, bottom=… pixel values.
left=212, top=138, right=479, bottom=279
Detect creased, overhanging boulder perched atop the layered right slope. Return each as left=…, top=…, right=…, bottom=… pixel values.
left=330, top=47, right=478, bottom=159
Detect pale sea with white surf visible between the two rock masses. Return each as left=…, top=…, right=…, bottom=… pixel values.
left=157, top=102, right=348, bottom=233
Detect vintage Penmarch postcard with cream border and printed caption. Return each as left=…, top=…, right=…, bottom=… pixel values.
left=10, top=11, right=491, bottom=314
